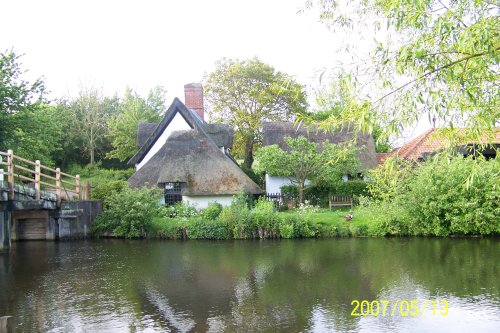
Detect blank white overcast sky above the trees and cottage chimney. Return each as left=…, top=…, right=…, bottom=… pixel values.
left=0, top=0, right=354, bottom=100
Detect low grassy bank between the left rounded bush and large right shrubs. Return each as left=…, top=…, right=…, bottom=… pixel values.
left=147, top=209, right=377, bottom=240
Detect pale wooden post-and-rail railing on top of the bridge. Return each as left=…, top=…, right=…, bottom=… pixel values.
left=0, top=150, right=90, bottom=204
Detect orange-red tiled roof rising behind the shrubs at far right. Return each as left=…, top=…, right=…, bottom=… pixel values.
left=392, top=128, right=500, bottom=160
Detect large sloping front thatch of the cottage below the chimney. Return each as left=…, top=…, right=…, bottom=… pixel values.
left=129, top=129, right=261, bottom=195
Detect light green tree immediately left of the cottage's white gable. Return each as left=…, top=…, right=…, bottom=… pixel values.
left=106, top=87, right=166, bottom=161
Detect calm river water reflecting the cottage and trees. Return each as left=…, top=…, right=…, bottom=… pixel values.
left=0, top=239, right=500, bottom=332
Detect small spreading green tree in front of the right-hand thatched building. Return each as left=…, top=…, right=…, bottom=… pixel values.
left=257, top=136, right=360, bottom=203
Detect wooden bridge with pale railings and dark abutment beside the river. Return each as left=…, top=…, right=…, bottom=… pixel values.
left=0, top=150, right=101, bottom=250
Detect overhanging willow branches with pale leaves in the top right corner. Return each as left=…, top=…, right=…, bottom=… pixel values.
left=309, top=0, right=500, bottom=140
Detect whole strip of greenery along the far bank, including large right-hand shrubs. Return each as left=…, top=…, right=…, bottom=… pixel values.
left=93, top=155, right=500, bottom=239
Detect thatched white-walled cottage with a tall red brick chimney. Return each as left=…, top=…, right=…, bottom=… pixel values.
left=128, top=84, right=261, bottom=208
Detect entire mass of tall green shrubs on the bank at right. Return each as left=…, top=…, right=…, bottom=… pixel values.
left=370, top=155, right=500, bottom=236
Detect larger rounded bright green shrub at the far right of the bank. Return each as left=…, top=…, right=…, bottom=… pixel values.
left=405, top=156, right=500, bottom=236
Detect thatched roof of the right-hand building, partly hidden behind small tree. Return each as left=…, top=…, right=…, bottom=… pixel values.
left=262, top=121, right=377, bottom=170
